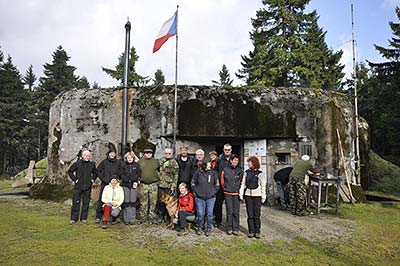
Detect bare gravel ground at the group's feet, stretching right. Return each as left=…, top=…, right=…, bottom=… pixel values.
left=117, top=204, right=355, bottom=245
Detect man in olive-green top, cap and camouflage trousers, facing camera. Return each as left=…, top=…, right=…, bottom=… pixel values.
left=138, top=148, right=160, bottom=224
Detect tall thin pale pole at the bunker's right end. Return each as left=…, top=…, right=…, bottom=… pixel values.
left=351, top=4, right=361, bottom=184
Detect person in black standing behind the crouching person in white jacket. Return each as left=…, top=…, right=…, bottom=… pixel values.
left=96, top=143, right=124, bottom=223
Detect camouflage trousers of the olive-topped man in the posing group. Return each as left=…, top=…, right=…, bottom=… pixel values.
left=139, top=182, right=158, bottom=222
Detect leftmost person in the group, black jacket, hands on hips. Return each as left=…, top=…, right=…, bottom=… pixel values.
left=68, top=150, right=97, bottom=224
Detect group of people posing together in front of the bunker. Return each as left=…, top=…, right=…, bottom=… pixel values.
left=68, top=144, right=266, bottom=238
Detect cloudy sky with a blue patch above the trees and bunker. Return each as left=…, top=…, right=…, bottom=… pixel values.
left=0, top=0, right=400, bottom=87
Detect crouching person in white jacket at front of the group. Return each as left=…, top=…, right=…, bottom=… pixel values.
left=101, top=178, right=124, bottom=229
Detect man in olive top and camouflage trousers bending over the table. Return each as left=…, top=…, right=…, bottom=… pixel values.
left=289, top=155, right=312, bottom=216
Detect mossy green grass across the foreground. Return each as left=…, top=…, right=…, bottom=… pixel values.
left=0, top=199, right=400, bottom=266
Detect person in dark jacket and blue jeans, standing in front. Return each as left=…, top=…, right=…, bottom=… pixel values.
left=191, top=159, right=219, bottom=236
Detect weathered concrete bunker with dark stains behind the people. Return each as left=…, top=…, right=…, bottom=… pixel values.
left=37, top=86, right=354, bottom=202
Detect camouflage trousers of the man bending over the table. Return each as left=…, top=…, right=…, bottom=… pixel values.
left=288, top=176, right=307, bottom=215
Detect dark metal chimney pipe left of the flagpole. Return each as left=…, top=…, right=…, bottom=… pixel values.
left=121, top=18, right=131, bottom=157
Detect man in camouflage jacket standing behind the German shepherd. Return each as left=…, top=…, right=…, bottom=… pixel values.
left=158, top=148, right=179, bottom=221
